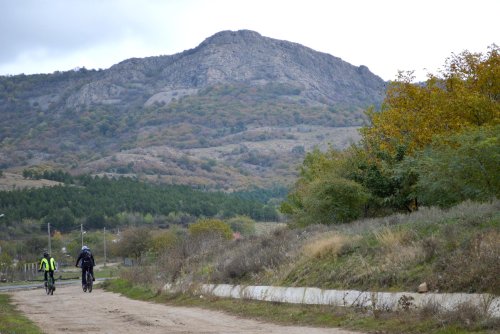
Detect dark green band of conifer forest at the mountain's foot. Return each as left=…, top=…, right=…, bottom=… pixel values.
left=0, top=172, right=278, bottom=231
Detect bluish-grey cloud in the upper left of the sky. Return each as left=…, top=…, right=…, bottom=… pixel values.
left=0, top=0, right=175, bottom=63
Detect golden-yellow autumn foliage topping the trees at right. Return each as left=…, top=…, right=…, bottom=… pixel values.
left=362, top=45, right=500, bottom=154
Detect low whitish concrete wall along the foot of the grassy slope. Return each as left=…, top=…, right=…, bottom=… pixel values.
left=201, top=284, right=500, bottom=318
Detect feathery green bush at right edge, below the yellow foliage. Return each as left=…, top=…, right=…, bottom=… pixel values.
left=406, top=126, right=500, bottom=206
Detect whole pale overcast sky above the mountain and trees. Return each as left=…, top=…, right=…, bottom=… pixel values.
left=0, top=0, right=500, bottom=80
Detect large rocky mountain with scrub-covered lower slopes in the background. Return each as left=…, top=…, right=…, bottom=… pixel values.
left=0, top=30, right=385, bottom=189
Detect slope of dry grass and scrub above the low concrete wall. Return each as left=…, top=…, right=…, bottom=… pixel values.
left=114, top=200, right=500, bottom=294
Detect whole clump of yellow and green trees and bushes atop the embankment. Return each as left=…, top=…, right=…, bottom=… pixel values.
left=281, top=45, right=500, bottom=225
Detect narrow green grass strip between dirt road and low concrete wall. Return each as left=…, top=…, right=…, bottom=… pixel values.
left=102, top=279, right=498, bottom=334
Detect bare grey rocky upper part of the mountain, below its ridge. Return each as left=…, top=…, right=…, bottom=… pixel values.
left=62, top=30, right=385, bottom=107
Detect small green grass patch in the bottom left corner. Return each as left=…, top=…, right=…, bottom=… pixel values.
left=0, top=294, right=43, bottom=334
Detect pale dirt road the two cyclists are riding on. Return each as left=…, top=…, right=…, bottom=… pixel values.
left=11, top=285, right=354, bottom=334
